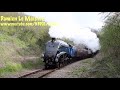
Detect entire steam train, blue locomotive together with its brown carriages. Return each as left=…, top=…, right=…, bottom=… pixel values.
left=42, top=38, right=98, bottom=69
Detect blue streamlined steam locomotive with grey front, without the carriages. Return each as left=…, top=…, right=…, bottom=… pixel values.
left=42, top=38, right=76, bottom=68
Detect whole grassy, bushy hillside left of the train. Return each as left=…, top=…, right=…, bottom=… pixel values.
left=0, top=12, right=50, bottom=77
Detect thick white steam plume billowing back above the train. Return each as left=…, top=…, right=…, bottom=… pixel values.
left=49, top=25, right=100, bottom=52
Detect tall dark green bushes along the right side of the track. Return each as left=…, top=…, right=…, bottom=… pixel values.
left=90, top=12, right=120, bottom=78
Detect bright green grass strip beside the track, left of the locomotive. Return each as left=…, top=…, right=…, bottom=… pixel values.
left=0, top=59, right=44, bottom=77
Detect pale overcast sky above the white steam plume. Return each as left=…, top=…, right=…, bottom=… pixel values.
left=25, top=12, right=103, bottom=29
